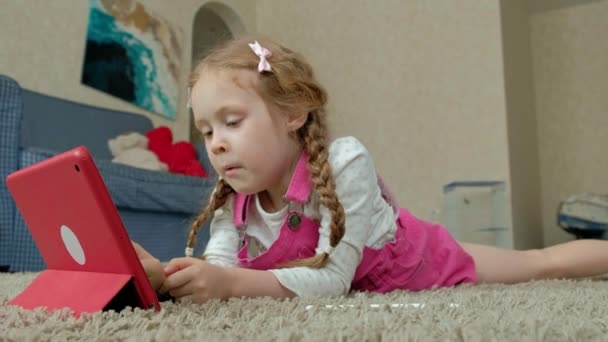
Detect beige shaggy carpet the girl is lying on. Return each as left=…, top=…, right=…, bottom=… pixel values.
left=0, top=273, right=608, bottom=341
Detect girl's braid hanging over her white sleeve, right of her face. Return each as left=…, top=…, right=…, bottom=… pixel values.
left=280, top=110, right=345, bottom=268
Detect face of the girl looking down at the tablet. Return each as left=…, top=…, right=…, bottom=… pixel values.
left=191, top=70, right=300, bottom=196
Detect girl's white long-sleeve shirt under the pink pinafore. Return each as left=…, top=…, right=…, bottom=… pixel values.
left=204, top=137, right=396, bottom=297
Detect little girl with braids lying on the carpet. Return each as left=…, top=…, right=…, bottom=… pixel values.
left=134, top=38, right=608, bottom=303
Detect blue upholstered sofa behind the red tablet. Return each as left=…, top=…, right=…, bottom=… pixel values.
left=0, top=75, right=216, bottom=272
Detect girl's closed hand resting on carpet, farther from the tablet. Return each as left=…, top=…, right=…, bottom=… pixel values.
left=159, top=258, right=231, bottom=304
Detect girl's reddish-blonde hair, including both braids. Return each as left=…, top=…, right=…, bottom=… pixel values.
left=188, top=37, right=344, bottom=268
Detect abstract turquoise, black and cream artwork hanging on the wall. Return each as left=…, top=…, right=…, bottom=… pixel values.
left=81, top=0, right=182, bottom=119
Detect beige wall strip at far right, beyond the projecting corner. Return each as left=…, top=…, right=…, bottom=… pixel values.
left=530, top=0, right=608, bottom=245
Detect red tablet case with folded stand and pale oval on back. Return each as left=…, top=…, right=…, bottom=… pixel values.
left=7, top=146, right=160, bottom=316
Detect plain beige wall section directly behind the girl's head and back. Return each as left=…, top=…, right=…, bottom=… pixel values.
left=257, top=0, right=509, bottom=227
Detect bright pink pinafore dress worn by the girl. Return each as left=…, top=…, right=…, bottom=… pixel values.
left=233, top=153, right=477, bottom=293
